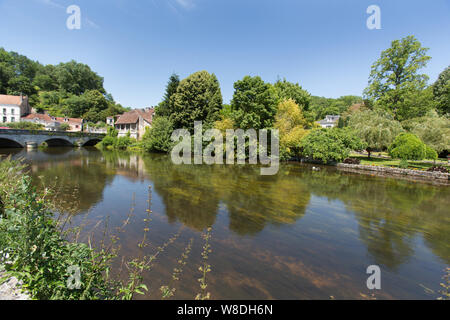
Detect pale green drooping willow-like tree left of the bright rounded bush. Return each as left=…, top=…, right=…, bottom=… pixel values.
left=348, top=110, right=403, bottom=158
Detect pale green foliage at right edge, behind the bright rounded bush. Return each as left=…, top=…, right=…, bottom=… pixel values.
left=402, top=112, right=450, bottom=153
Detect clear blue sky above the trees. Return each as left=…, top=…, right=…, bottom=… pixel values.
left=0, top=0, right=450, bottom=108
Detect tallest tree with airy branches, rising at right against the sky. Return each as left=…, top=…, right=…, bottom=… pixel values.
left=364, top=36, right=431, bottom=120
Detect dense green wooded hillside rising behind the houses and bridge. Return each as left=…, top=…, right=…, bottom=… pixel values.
left=0, top=48, right=126, bottom=122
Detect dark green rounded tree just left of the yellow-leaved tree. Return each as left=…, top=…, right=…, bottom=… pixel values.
left=231, top=76, right=278, bottom=130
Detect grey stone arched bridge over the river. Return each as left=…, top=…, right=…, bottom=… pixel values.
left=0, top=129, right=105, bottom=148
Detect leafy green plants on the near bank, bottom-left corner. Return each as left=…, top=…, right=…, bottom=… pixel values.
left=0, top=162, right=114, bottom=299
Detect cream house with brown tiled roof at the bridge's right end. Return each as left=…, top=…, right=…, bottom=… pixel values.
left=114, top=108, right=155, bottom=140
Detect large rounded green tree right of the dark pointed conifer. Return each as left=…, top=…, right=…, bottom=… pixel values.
left=170, top=71, right=222, bottom=131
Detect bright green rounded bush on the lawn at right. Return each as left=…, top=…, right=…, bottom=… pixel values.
left=388, top=133, right=426, bottom=160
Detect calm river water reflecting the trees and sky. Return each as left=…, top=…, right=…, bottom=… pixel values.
left=0, top=148, right=450, bottom=299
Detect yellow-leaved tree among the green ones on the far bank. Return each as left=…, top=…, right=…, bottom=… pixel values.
left=274, top=99, right=307, bottom=159
